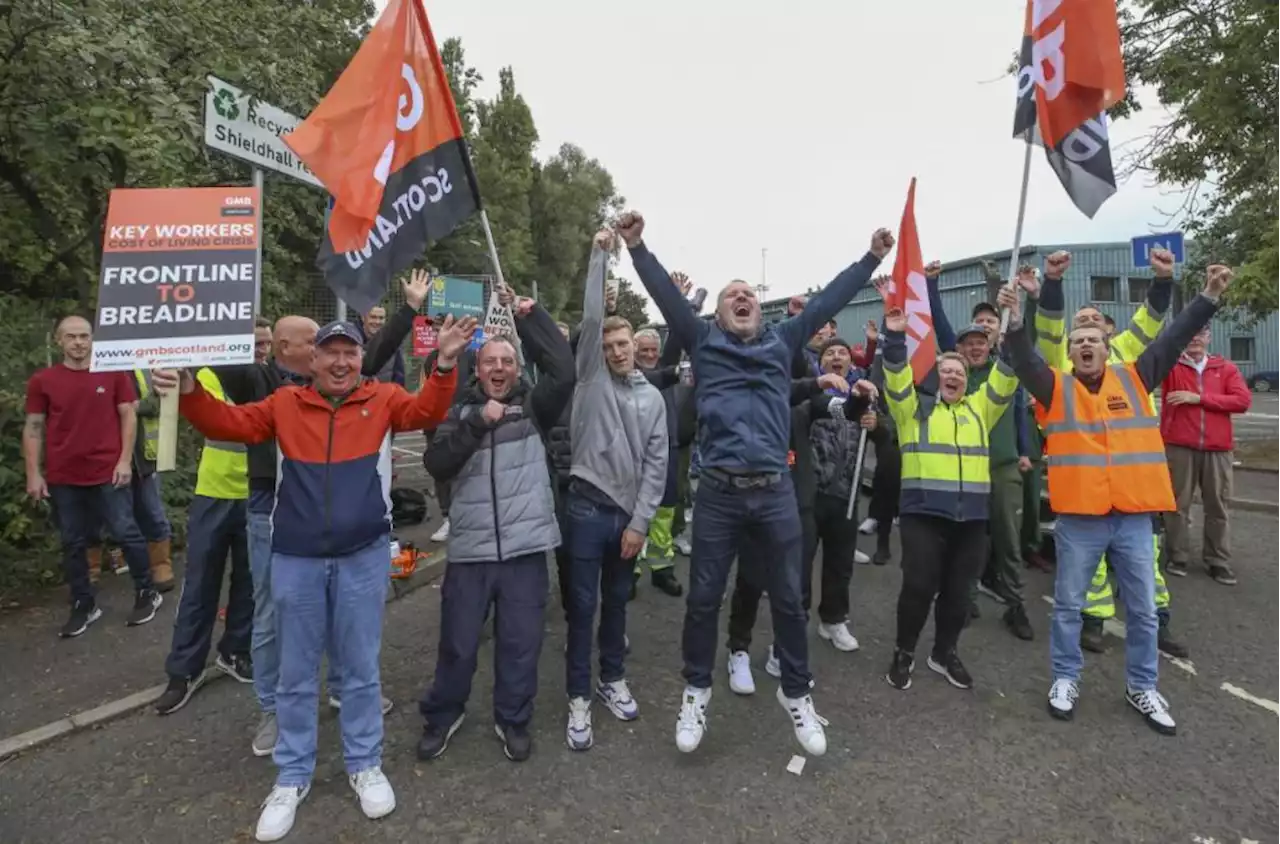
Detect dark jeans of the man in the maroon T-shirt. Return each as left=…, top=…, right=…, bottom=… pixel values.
left=49, top=484, right=151, bottom=605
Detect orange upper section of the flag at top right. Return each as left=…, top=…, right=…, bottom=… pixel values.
left=1019, top=0, right=1125, bottom=149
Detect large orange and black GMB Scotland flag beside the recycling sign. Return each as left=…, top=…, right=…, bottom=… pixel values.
left=284, top=0, right=480, bottom=312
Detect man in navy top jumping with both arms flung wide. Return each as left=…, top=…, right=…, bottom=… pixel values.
left=617, top=211, right=893, bottom=756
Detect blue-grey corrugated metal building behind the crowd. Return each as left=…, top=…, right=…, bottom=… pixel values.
left=762, top=242, right=1280, bottom=377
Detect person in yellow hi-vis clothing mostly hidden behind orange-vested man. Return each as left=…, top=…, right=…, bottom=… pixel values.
left=1020, top=248, right=1189, bottom=657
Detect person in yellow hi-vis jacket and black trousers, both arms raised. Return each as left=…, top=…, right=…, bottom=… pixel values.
left=884, top=303, right=1018, bottom=690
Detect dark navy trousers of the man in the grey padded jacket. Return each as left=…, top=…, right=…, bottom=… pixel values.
left=417, top=553, right=548, bottom=730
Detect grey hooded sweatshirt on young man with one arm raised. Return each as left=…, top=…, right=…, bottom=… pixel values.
left=570, top=245, right=667, bottom=535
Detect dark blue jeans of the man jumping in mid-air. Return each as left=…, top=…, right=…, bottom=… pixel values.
left=684, top=469, right=810, bottom=698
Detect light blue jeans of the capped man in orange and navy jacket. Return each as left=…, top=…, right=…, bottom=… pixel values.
left=271, top=537, right=392, bottom=788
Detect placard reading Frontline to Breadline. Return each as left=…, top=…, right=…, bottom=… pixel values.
left=91, top=187, right=261, bottom=371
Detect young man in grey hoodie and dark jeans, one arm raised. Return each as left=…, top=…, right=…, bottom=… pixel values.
left=564, top=229, right=668, bottom=751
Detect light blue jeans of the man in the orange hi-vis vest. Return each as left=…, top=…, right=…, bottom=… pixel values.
left=1050, top=514, right=1160, bottom=690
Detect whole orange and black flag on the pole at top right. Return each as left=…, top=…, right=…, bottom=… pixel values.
left=1014, top=0, right=1125, bottom=218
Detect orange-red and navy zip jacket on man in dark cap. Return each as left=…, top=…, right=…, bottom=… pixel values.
left=178, top=368, right=457, bottom=558
